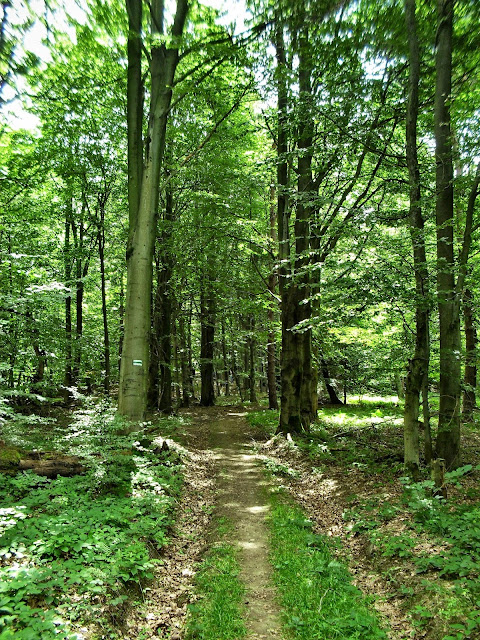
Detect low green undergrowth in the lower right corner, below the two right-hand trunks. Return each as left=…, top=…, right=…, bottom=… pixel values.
left=344, top=465, right=480, bottom=640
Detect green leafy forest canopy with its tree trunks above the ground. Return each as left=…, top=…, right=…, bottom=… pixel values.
left=0, top=0, right=480, bottom=468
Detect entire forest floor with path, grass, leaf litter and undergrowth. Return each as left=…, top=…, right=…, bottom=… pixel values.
left=0, top=399, right=480, bottom=640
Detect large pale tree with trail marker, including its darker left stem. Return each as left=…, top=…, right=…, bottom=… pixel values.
left=118, top=0, right=188, bottom=420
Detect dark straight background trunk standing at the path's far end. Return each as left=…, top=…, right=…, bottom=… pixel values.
left=200, top=278, right=215, bottom=407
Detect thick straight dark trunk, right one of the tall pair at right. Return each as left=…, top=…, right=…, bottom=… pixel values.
left=435, top=0, right=460, bottom=470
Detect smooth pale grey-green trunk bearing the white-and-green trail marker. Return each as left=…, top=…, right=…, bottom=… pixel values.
left=118, top=0, right=188, bottom=420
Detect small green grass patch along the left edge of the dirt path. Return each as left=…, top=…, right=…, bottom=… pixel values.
left=186, top=520, right=247, bottom=640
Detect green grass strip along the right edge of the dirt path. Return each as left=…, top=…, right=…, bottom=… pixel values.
left=271, top=494, right=387, bottom=640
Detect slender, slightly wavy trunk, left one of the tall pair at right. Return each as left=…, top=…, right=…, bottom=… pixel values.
left=404, top=0, right=431, bottom=477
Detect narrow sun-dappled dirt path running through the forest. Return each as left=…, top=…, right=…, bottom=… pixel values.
left=183, top=407, right=282, bottom=640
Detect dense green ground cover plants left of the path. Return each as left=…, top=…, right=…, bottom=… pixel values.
left=0, top=403, right=186, bottom=640
